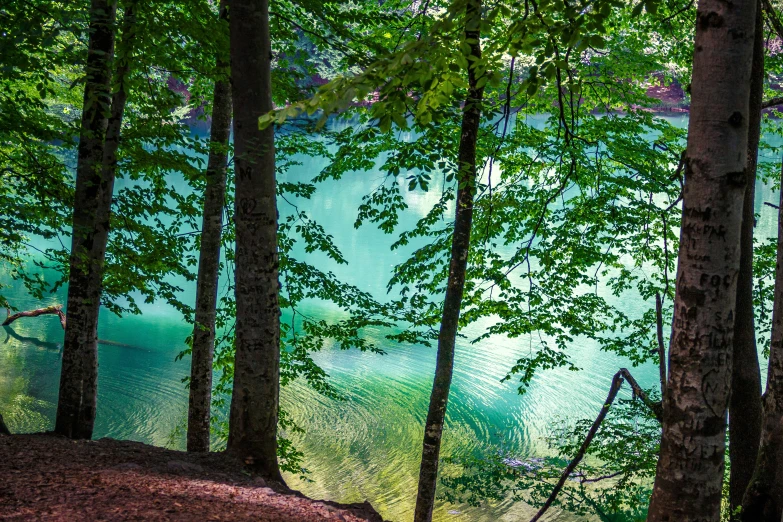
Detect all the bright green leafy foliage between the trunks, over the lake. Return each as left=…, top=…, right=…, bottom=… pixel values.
left=0, top=0, right=782, bottom=520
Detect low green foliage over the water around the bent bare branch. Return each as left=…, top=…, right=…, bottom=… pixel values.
left=442, top=399, right=660, bottom=522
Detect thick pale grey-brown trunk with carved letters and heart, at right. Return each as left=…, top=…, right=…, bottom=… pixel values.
left=647, top=0, right=757, bottom=522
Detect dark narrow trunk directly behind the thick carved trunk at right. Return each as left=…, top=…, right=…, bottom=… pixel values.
left=729, top=5, right=764, bottom=512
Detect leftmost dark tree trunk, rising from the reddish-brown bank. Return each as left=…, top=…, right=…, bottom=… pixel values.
left=55, top=0, right=117, bottom=438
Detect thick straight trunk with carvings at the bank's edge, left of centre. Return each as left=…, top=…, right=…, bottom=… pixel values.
left=228, top=0, right=282, bottom=482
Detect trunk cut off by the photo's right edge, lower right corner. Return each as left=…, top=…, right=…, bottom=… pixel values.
left=742, top=161, right=783, bottom=522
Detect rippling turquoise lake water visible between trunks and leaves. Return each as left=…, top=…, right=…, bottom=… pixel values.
left=0, top=115, right=777, bottom=521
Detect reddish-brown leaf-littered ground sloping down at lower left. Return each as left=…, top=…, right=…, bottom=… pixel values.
left=0, top=434, right=382, bottom=522
